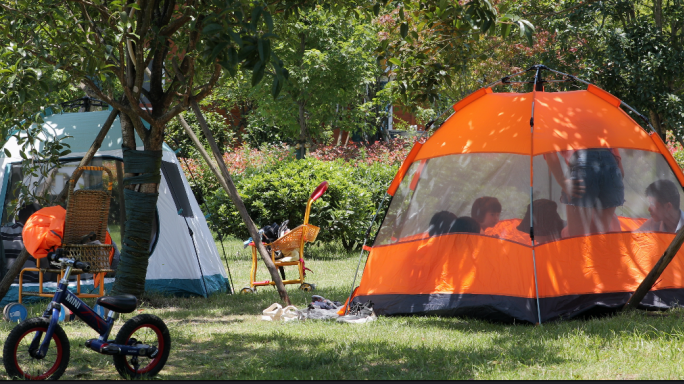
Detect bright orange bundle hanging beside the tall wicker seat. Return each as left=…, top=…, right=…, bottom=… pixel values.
left=21, top=205, right=66, bottom=259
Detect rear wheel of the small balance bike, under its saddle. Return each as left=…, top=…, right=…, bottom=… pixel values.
left=113, top=314, right=171, bottom=379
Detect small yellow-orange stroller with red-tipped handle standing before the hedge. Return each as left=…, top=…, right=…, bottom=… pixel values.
left=240, top=181, right=328, bottom=293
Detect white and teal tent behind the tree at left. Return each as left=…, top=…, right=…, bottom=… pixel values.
left=0, top=111, right=227, bottom=303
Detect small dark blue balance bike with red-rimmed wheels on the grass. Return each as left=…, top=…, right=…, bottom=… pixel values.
left=2, top=249, right=171, bottom=380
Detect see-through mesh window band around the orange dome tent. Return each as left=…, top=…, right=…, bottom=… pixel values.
left=375, top=148, right=684, bottom=246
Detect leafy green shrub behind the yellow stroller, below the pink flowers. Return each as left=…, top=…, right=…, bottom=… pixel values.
left=205, top=157, right=398, bottom=249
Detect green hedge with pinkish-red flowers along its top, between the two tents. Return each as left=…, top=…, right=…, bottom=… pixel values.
left=181, top=139, right=411, bottom=249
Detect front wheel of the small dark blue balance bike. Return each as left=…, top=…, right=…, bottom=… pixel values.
left=2, top=317, right=69, bottom=380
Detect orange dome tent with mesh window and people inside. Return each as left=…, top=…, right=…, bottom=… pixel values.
left=352, top=66, right=684, bottom=323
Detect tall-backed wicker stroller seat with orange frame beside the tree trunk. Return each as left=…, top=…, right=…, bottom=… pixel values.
left=19, top=166, right=113, bottom=303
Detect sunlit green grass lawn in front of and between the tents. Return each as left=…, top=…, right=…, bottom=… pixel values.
left=0, top=239, right=684, bottom=380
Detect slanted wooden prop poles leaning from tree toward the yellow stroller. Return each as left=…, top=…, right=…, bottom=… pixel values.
left=178, top=102, right=290, bottom=305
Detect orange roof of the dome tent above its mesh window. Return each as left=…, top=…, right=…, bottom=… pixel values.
left=414, top=90, right=660, bottom=161
